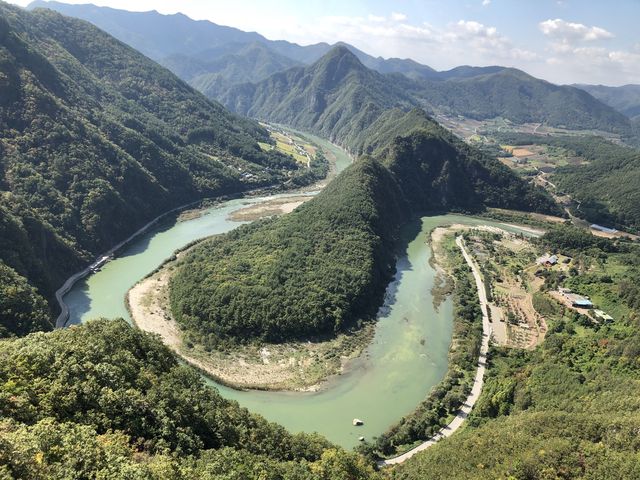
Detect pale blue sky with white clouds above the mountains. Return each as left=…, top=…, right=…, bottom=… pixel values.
left=10, top=0, right=640, bottom=85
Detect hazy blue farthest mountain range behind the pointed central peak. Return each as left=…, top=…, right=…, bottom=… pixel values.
left=28, top=0, right=632, bottom=133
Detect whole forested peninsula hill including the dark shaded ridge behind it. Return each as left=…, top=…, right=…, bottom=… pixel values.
left=170, top=112, right=555, bottom=348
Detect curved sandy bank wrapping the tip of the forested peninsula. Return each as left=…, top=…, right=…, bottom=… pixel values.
left=127, top=263, right=374, bottom=391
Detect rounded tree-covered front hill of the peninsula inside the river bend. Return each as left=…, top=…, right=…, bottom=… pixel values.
left=171, top=159, right=407, bottom=347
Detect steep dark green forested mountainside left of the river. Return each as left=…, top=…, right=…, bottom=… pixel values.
left=0, top=2, right=304, bottom=333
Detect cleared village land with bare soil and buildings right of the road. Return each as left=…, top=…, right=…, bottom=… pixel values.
left=432, top=225, right=613, bottom=349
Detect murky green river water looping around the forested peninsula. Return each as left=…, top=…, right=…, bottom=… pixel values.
left=64, top=133, right=536, bottom=447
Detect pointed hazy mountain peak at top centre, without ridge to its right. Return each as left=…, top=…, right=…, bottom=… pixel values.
left=221, top=46, right=415, bottom=147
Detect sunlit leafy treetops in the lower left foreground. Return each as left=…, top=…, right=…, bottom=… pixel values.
left=0, top=320, right=375, bottom=480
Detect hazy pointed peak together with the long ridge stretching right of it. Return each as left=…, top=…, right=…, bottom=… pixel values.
left=217, top=46, right=633, bottom=144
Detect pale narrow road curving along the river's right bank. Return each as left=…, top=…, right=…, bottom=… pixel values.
left=378, top=237, right=491, bottom=467
